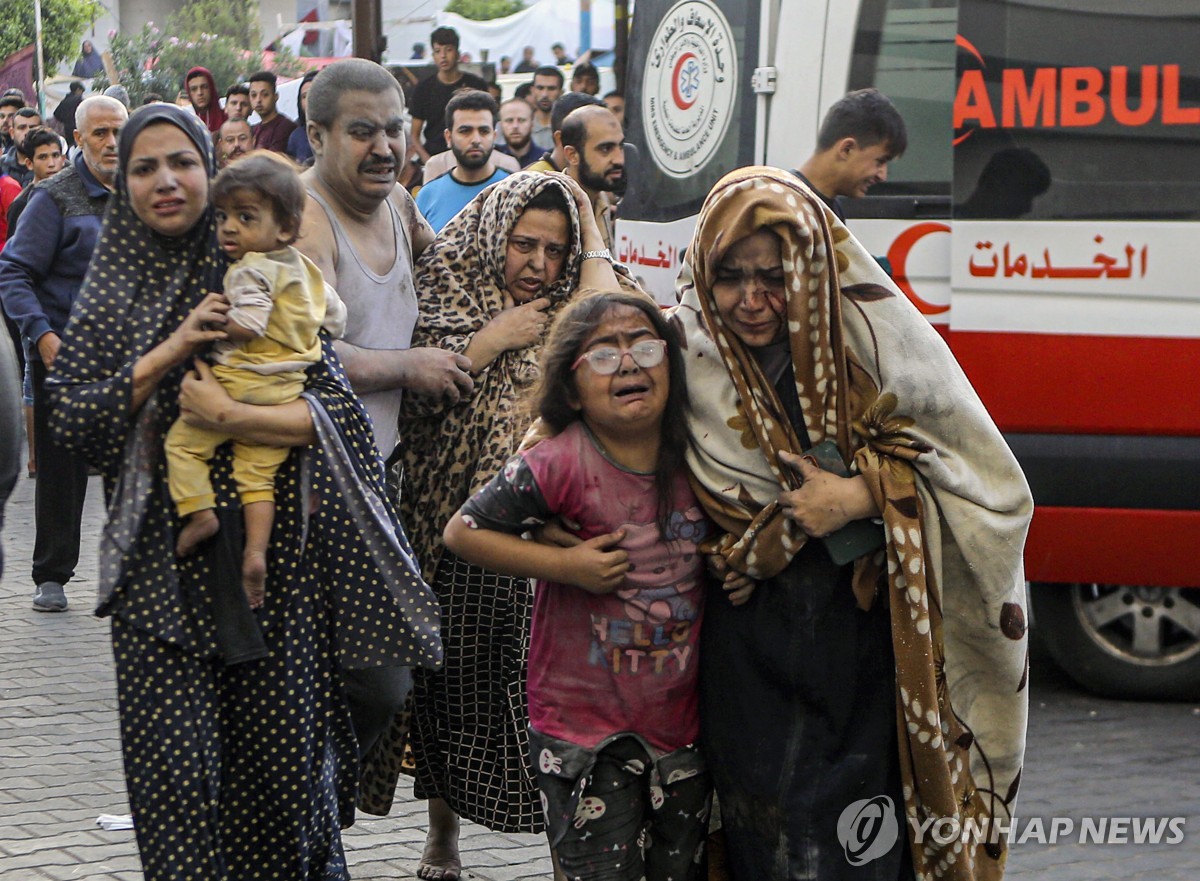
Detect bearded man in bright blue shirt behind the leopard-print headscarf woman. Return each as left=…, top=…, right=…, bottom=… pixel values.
left=416, top=89, right=509, bottom=233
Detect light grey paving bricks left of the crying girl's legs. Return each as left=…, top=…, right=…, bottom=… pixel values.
left=0, top=477, right=551, bottom=881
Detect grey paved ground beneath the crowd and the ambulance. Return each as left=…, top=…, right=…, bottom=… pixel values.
left=0, top=478, right=1200, bottom=881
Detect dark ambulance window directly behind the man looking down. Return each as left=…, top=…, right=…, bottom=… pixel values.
left=844, top=0, right=958, bottom=206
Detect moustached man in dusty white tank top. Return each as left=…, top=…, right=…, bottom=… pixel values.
left=296, top=59, right=473, bottom=459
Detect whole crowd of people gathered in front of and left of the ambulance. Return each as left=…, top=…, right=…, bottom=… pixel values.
left=0, top=20, right=1032, bottom=881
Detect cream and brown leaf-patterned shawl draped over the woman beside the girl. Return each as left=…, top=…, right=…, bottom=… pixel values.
left=674, top=168, right=1032, bottom=879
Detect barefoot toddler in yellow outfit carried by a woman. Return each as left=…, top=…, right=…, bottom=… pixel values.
left=166, top=151, right=346, bottom=609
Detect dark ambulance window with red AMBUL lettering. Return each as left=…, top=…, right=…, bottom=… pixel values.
left=954, top=0, right=1200, bottom=220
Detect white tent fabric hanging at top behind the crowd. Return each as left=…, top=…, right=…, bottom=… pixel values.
left=383, top=0, right=616, bottom=66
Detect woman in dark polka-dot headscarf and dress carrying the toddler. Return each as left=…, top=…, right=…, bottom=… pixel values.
left=50, top=104, right=442, bottom=881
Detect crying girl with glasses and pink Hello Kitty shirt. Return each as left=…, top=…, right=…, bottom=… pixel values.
left=444, top=293, right=754, bottom=879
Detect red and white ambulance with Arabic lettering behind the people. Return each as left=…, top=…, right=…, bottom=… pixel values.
left=614, top=0, right=1200, bottom=700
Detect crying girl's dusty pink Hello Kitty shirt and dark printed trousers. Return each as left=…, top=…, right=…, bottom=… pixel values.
left=462, top=421, right=710, bottom=881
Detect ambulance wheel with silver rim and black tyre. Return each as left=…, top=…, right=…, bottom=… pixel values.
left=1031, top=583, right=1200, bottom=701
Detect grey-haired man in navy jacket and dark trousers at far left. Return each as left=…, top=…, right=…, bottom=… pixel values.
left=0, top=96, right=128, bottom=612
